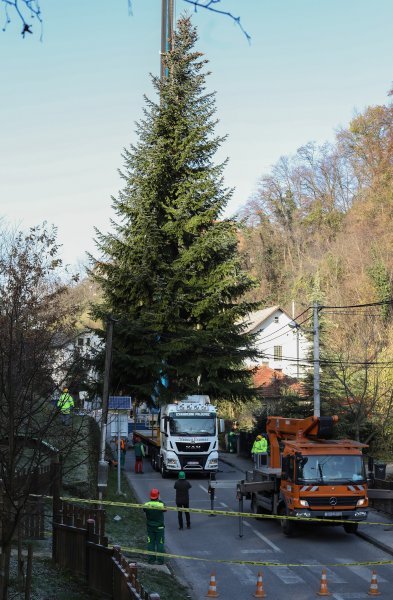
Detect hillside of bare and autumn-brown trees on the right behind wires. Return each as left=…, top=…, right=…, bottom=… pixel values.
left=241, top=92, right=393, bottom=448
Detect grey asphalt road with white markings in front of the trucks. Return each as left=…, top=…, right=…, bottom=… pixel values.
left=125, top=460, right=393, bottom=600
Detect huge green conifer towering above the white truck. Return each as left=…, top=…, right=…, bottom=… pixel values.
left=92, top=18, right=255, bottom=402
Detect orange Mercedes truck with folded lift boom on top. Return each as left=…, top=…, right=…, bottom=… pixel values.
left=237, top=416, right=368, bottom=536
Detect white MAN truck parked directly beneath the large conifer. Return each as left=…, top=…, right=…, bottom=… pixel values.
left=134, top=395, right=220, bottom=478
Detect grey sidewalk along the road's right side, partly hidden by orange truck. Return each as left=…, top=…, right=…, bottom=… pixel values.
left=220, top=452, right=393, bottom=556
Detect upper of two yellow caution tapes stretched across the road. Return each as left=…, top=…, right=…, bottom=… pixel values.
left=30, top=494, right=393, bottom=527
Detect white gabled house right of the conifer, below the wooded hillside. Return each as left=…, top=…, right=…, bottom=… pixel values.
left=246, top=306, right=312, bottom=379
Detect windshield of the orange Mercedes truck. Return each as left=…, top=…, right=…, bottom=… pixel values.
left=296, top=455, right=366, bottom=484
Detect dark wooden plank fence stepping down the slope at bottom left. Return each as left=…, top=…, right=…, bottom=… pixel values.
left=52, top=501, right=160, bottom=600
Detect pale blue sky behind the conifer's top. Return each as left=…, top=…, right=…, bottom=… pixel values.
left=0, top=0, right=393, bottom=265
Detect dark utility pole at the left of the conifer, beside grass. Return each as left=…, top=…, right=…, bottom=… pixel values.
left=98, top=315, right=114, bottom=500
